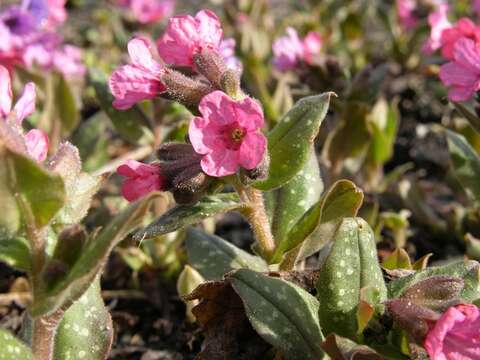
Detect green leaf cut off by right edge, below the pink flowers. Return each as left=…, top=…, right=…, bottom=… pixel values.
left=445, top=130, right=480, bottom=202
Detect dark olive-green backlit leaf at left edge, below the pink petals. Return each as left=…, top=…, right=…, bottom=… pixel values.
left=0, top=149, right=65, bottom=228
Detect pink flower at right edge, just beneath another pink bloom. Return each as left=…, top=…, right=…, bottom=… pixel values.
left=440, top=38, right=480, bottom=101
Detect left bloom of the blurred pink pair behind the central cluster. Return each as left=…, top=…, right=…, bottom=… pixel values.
left=272, top=27, right=303, bottom=71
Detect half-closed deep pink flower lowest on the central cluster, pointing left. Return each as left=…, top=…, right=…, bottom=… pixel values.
left=117, top=160, right=165, bottom=201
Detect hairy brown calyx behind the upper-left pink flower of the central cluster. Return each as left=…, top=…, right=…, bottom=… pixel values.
left=161, top=69, right=213, bottom=112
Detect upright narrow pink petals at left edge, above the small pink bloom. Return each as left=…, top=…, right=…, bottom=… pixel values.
left=0, top=65, right=36, bottom=125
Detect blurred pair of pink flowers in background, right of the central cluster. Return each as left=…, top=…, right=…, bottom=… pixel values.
left=272, top=27, right=323, bottom=71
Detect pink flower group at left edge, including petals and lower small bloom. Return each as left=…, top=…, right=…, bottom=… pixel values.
left=0, top=65, right=48, bottom=162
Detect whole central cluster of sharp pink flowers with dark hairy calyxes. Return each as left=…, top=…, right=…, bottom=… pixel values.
left=109, top=10, right=267, bottom=202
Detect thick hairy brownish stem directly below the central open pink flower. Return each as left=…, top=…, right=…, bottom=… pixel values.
left=234, top=180, right=275, bottom=259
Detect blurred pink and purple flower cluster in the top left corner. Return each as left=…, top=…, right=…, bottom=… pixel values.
left=0, top=0, right=85, bottom=76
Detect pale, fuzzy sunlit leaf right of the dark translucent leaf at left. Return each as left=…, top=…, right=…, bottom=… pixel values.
left=48, top=142, right=106, bottom=225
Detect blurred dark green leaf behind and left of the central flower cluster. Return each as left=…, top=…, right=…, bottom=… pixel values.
left=89, top=71, right=153, bottom=144
